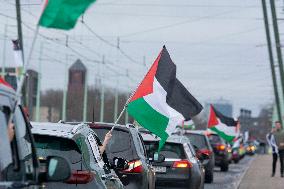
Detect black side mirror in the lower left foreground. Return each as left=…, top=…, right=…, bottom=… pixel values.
left=45, top=156, right=71, bottom=182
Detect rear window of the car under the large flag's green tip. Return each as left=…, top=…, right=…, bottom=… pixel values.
left=144, top=141, right=186, bottom=159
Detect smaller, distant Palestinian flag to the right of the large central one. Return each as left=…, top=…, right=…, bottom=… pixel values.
left=208, top=105, right=239, bottom=142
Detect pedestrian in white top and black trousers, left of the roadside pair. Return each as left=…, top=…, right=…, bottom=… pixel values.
left=266, top=128, right=278, bottom=177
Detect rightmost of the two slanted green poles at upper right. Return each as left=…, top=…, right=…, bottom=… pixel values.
left=270, top=0, right=284, bottom=105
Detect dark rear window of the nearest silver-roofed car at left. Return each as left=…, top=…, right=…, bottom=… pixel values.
left=34, top=134, right=81, bottom=164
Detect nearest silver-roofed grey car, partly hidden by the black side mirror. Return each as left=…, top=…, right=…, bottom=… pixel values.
left=32, top=123, right=124, bottom=189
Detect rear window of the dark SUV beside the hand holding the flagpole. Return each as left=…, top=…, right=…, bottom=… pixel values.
left=94, top=128, right=138, bottom=160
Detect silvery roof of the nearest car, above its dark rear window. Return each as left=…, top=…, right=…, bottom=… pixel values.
left=31, top=122, right=89, bottom=139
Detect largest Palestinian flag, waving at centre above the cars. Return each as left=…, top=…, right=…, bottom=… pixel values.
left=127, top=47, right=202, bottom=149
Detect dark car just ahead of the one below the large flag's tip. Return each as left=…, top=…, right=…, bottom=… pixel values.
left=184, top=130, right=215, bottom=183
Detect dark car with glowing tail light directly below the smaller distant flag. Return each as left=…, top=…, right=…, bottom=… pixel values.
left=207, top=133, right=230, bottom=172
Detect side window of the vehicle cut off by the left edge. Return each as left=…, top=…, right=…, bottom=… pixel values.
left=0, top=111, right=12, bottom=173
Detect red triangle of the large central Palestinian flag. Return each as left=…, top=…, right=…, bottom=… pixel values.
left=129, top=49, right=164, bottom=102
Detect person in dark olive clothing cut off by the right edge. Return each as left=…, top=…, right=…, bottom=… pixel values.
left=274, top=121, right=284, bottom=177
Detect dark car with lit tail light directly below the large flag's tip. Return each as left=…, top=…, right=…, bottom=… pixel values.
left=142, top=133, right=205, bottom=189
